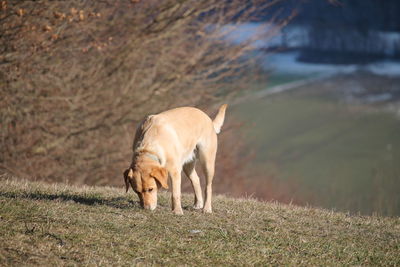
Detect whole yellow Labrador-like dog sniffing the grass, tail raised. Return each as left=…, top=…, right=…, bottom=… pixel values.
left=124, top=104, right=227, bottom=215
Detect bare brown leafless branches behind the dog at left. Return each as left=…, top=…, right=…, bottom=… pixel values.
left=0, top=0, right=292, bottom=185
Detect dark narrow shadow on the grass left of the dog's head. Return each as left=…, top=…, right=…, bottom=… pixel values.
left=0, top=192, right=140, bottom=209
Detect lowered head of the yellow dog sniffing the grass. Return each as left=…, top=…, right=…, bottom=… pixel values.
left=124, top=165, right=168, bottom=210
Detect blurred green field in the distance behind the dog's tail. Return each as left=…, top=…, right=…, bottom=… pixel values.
left=232, top=74, right=400, bottom=215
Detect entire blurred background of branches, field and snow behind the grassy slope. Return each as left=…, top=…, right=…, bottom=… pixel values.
left=0, top=0, right=400, bottom=216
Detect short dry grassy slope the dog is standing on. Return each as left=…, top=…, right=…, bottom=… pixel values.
left=0, top=177, right=400, bottom=266
